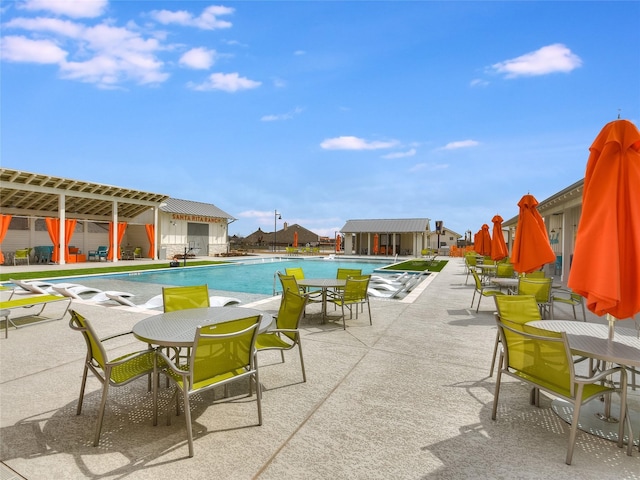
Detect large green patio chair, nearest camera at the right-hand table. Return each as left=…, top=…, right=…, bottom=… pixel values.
left=491, top=320, right=631, bottom=465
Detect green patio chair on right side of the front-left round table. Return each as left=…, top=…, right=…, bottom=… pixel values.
left=256, top=290, right=309, bottom=382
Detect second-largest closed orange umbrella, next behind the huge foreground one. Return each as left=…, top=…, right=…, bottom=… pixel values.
left=511, top=194, right=556, bottom=273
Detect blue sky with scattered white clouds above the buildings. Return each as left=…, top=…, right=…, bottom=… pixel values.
left=0, top=0, right=640, bottom=237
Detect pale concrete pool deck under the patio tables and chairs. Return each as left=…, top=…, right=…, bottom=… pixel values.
left=0, top=258, right=640, bottom=480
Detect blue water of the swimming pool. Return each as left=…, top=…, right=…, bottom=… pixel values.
left=60, top=259, right=389, bottom=295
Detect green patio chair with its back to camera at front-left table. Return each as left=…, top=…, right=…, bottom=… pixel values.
left=154, top=315, right=262, bottom=457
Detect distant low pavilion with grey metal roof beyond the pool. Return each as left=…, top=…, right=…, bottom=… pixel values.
left=340, top=218, right=435, bottom=257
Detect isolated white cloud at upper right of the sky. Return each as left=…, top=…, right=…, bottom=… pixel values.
left=491, top=43, right=582, bottom=78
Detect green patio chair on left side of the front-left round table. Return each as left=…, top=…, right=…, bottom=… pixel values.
left=69, top=310, right=156, bottom=447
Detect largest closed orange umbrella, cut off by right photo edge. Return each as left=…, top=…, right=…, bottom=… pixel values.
left=568, top=120, right=640, bottom=319
